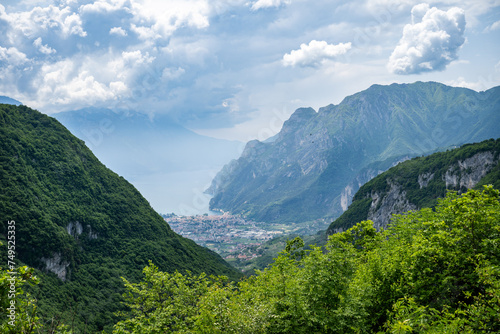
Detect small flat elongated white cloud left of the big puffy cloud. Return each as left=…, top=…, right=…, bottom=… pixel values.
left=283, top=40, right=351, bottom=67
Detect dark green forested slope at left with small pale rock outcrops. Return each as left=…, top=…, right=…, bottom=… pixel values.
left=0, top=104, right=241, bottom=333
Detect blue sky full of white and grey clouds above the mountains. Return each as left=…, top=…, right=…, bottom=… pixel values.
left=0, top=0, right=500, bottom=141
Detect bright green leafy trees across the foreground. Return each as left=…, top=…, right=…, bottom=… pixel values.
left=0, top=186, right=500, bottom=334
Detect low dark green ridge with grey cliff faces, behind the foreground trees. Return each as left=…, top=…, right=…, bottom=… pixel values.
left=327, top=139, right=500, bottom=234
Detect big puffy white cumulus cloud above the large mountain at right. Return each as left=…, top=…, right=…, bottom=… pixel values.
left=388, top=3, right=465, bottom=74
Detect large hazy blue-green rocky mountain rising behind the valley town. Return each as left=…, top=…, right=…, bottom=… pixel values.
left=207, top=82, right=500, bottom=223
